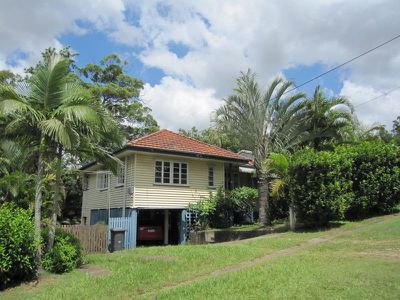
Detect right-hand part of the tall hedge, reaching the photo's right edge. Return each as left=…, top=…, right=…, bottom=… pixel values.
left=337, top=142, right=400, bottom=219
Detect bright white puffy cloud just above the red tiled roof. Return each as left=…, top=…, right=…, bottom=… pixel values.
left=141, top=76, right=220, bottom=130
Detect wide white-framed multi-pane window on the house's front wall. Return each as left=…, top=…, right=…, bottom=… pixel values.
left=154, top=160, right=188, bottom=185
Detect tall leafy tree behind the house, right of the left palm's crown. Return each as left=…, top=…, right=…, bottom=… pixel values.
left=77, top=54, right=159, bottom=139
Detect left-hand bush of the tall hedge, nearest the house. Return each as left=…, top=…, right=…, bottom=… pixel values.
left=289, top=149, right=354, bottom=226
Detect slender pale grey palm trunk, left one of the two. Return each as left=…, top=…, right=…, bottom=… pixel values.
left=35, top=138, right=44, bottom=262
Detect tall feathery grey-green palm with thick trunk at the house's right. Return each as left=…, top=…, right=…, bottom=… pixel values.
left=216, top=70, right=308, bottom=225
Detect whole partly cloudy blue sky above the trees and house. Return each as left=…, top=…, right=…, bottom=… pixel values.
left=0, top=0, right=400, bottom=130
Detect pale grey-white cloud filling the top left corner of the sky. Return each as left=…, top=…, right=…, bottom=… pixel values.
left=0, top=0, right=131, bottom=70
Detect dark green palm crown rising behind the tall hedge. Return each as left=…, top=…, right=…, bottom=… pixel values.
left=306, top=86, right=356, bottom=150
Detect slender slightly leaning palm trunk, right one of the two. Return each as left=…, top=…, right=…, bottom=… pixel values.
left=47, top=146, right=62, bottom=250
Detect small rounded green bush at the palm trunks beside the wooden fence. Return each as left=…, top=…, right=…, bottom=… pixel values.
left=42, top=228, right=82, bottom=273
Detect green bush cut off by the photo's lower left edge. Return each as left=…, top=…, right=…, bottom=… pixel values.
left=0, top=204, right=37, bottom=289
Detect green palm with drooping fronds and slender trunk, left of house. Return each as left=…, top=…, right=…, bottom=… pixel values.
left=0, top=54, right=119, bottom=259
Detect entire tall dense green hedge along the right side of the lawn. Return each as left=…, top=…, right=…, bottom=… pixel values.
left=289, top=142, right=400, bottom=225
